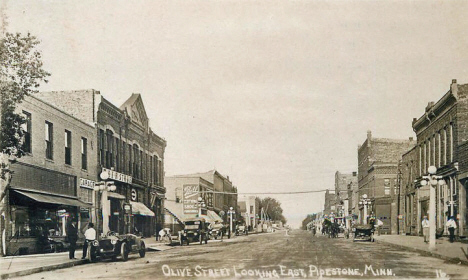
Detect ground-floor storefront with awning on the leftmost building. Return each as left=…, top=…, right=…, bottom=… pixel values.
left=2, top=163, right=92, bottom=255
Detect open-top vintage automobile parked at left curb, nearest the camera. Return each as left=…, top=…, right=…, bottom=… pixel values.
left=87, top=231, right=146, bottom=262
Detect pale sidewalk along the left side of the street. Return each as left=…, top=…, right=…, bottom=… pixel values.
left=0, top=238, right=167, bottom=279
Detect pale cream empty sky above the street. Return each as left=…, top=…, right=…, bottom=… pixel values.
left=0, top=0, right=468, bottom=227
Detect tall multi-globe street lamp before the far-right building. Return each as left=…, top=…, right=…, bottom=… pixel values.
left=421, top=166, right=445, bottom=250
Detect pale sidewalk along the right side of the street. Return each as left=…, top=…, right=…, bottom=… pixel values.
left=374, top=235, right=468, bottom=265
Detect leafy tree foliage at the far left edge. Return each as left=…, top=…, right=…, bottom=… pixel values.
left=0, top=33, right=50, bottom=157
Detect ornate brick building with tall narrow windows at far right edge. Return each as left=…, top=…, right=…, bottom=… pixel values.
left=413, top=80, right=468, bottom=236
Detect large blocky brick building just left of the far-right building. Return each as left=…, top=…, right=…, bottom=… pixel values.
left=358, top=131, right=415, bottom=233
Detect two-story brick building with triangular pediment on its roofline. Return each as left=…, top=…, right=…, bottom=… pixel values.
left=34, top=90, right=166, bottom=236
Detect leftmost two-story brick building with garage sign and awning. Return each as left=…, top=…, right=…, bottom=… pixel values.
left=0, top=96, right=98, bottom=255
